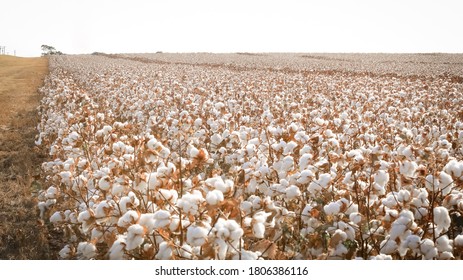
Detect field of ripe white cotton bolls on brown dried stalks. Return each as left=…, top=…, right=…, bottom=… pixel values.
left=36, top=54, right=463, bottom=260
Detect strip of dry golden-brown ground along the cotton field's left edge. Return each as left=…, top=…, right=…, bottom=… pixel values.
left=0, top=56, right=53, bottom=260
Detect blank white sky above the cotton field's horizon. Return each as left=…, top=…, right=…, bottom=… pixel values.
left=0, top=0, right=463, bottom=56
